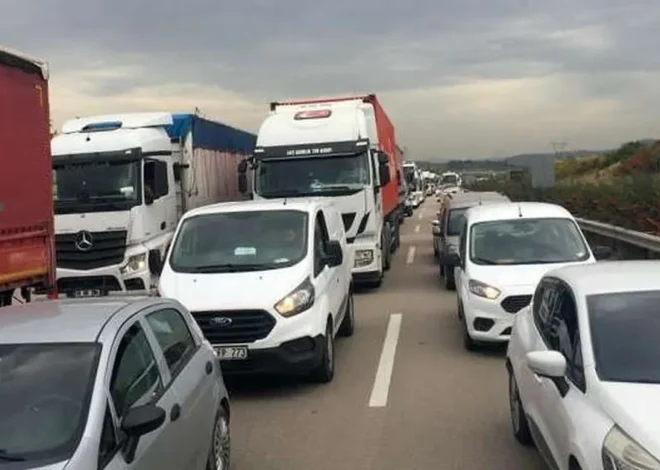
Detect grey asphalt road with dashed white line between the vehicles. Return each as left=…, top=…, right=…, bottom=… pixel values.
left=230, top=198, right=545, bottom=470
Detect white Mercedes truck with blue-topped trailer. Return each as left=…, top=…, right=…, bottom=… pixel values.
left=51, top=112, right=256, bottom=297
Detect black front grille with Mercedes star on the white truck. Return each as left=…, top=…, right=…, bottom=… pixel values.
left=55, top=230, right=127, bottom=270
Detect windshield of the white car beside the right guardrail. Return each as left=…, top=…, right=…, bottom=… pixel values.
left=470, top=218, right=590, bottom=265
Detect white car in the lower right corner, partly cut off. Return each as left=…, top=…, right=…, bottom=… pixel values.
left=506, top=261, right=660, bottom=470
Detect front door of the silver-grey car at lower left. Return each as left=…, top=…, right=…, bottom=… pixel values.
left=105, top=319, right=186, bottom=470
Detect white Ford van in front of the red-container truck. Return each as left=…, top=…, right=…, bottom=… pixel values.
left=159, top=199, right=355, bottom=382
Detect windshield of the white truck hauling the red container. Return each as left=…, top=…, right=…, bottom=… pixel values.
left=257, top=152, right=371, bottom=197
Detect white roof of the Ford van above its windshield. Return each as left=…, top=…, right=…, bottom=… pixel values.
left=184, top=197, right=326, bottom=218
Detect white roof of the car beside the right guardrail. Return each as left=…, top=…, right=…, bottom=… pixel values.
left=465, top=202, right=573, bottom=224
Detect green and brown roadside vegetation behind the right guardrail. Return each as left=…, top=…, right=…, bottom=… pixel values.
left=470, top=141, right=660, bottom=234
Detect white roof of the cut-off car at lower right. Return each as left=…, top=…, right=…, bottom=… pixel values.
left=546, top=260, right=660, bottom=296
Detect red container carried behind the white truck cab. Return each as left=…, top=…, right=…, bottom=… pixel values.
left=270, top=94, right=403, bottom=217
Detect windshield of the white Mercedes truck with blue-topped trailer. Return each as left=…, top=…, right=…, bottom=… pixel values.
left=53, top=161, right=141, bottom=214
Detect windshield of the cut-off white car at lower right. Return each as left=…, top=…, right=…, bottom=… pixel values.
left=587, top=291, right=660, bottom=384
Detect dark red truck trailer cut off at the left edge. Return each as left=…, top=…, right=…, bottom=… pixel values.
left=0, top=48, right=57, bottom=306
